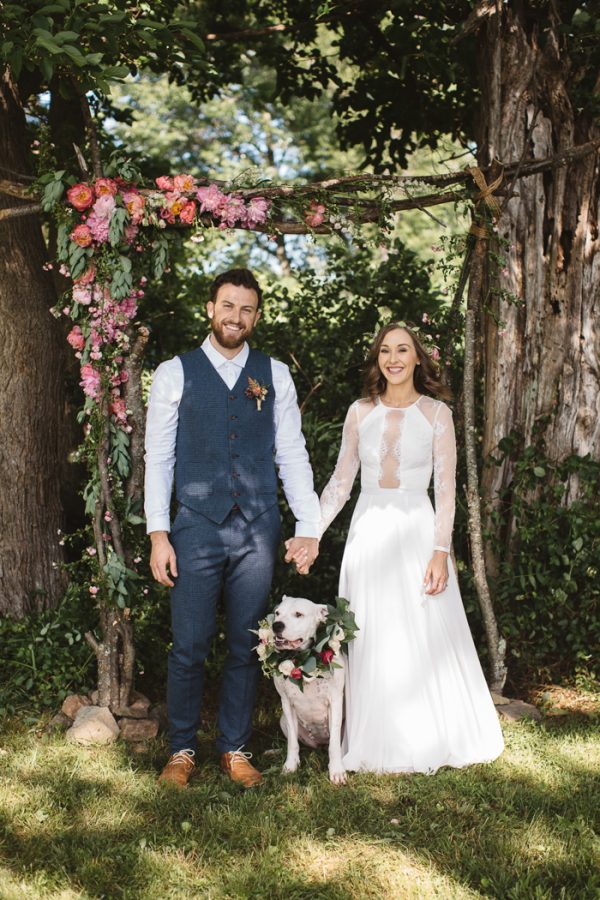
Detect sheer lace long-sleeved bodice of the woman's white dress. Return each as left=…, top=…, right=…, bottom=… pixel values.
left=320, top=395, right=456, bottom=552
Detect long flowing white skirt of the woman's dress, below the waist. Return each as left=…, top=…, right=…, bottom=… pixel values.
left=340, top=490, right=504, bottom=773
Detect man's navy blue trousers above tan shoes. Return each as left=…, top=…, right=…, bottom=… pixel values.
left=167, top=506, right=281, bottom=753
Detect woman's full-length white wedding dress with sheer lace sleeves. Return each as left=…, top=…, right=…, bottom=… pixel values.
left=321, top=396, right=504, bottom=772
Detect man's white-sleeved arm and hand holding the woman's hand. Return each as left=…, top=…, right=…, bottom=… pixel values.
left=272, top=360, right=321, bottom=574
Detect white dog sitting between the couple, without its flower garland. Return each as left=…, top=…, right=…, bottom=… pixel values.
left=272, top=596, right=346, bottom=784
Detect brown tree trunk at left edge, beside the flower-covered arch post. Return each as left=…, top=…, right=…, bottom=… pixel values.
left=0, top=72, right=64, bottom=617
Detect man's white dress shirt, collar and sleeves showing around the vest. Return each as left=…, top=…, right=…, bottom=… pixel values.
left=144, top=337, right=321, bottom=537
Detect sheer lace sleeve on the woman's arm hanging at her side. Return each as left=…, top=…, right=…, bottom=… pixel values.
left=433, top=403, right=456, bottom=553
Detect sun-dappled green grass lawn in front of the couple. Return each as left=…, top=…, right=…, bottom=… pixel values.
left=0, top=701, right=600, bottom=900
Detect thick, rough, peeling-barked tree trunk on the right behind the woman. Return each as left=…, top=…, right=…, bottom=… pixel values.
left=478, top=0, right=600, bottom=520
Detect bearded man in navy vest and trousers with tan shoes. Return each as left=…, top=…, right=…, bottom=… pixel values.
left=145, top=269, right=320, bottom=787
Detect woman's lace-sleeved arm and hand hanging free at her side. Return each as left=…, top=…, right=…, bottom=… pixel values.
left=425, top=403, right=456, bottom=594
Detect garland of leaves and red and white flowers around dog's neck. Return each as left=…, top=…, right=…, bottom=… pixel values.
left=254, top=597, right=358, bottom=691
